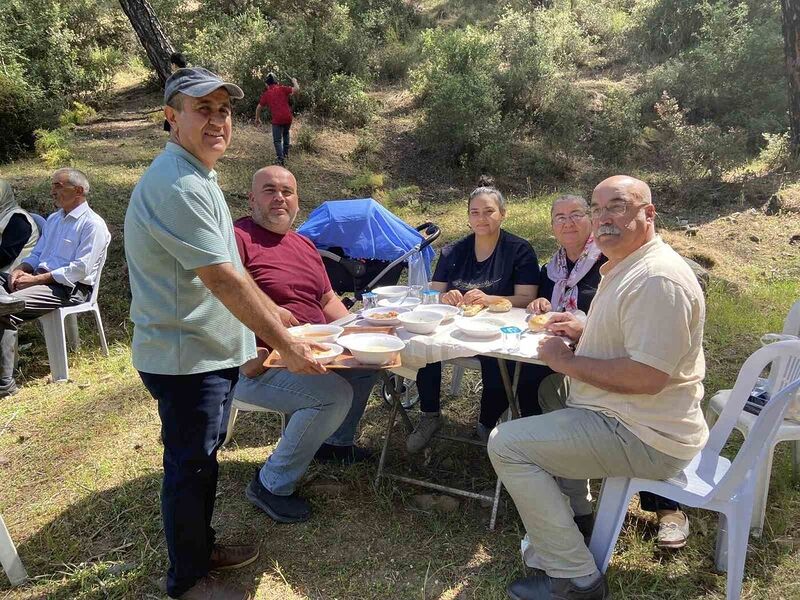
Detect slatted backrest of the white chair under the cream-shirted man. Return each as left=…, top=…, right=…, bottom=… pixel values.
left=697, top=340, right=800, bottom=497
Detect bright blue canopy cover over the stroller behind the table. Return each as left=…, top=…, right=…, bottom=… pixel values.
left=297, top=198, right=434, bottom=273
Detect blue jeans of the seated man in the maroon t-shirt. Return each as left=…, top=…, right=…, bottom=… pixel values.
left=236, top=369, right=377, bottom=496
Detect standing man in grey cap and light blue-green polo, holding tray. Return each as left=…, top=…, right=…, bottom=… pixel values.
left=125, top=68, right=325, bottom=600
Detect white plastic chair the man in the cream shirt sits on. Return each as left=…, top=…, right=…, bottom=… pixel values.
left=589, top=341, right=800, bottom=600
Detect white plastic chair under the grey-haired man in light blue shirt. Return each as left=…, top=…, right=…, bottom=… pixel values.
left=39, top=246, right=108, bottom=382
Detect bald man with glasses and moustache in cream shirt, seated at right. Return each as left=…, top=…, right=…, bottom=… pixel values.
left=488, top=176, right=708, bottom=600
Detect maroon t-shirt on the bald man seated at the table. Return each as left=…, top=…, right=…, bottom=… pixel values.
left=233, top=217, right=331, bottom=346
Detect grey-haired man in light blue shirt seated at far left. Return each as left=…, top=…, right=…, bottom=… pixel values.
left=0, top=168, right=111, bottom=398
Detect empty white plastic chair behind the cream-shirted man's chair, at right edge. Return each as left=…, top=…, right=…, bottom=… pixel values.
left=706, top=300, right=800, bottom=537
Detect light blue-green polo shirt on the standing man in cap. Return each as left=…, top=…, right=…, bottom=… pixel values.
left=125, top=142, right=256, bottom=375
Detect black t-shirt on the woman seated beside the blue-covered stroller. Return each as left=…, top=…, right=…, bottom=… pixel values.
left=433, top=229, right=539, bottom=296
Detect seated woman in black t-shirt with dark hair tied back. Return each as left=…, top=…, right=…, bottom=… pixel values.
left=406, top=186, right=539, bottom=452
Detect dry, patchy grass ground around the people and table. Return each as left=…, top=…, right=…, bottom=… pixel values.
left=0, top=72, right=800, bottom=600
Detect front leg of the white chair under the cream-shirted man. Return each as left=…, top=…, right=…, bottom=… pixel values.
left=589, top=477, right=631, bottom=573
